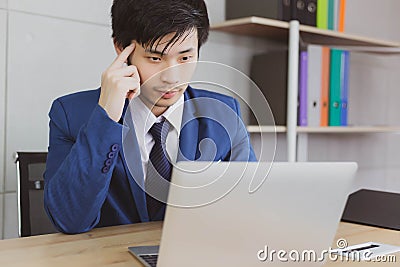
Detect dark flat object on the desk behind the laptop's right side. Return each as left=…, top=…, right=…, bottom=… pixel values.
left=342, top=189, right=400, bottom=230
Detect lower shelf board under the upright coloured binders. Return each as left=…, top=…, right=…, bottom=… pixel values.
left=247, top=125, right=400, bottom=134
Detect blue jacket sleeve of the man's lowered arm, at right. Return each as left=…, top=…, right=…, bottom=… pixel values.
left=230, top=99, right=257, bottom=161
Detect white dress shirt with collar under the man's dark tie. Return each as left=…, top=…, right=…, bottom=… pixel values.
left=129, top=95, right=184, bottom=179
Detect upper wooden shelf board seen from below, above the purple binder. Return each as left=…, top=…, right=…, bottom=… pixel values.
left=211, top=17, right=400, bottom=48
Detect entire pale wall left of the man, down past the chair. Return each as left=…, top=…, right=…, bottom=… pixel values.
left=0, top=0, right=115, bottom=238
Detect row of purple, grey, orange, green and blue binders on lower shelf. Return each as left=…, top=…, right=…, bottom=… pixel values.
left=298, top=45, right=350, bottom=127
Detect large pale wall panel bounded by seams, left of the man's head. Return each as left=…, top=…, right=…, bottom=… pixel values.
left=5, top=11, right=114, bottom=191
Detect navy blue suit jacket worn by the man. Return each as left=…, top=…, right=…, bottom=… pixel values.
left=44, top=86, right=256, bottom=233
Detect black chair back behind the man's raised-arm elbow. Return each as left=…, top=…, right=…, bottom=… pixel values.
left=15, top=152, right=57, bottom=237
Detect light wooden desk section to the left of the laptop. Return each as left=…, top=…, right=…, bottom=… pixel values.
left=0, top=223, right=161, bottom=267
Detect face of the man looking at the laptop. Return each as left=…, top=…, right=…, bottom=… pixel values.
left=129, top=30, right=198, bottom=116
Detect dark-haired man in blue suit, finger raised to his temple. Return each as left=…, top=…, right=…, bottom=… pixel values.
left=44, top=0, right=255, bottom=233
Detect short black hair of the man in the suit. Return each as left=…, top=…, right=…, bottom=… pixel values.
left=111, top=0, right=210, bottom=53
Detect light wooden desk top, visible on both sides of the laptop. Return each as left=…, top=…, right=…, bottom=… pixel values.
left=0, top=223, right=400, bottom=267
